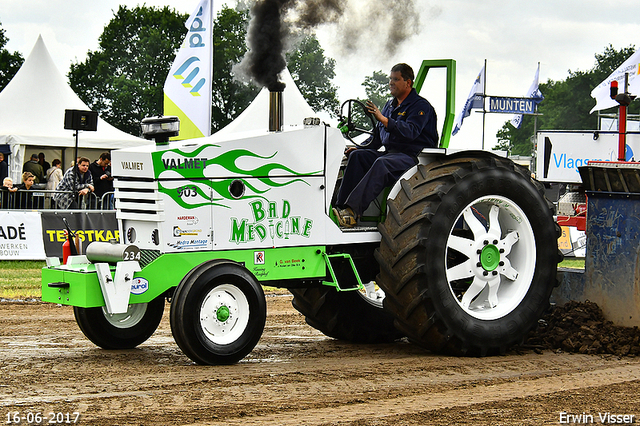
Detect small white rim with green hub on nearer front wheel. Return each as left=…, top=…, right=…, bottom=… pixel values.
left=200, top=284, right=249, bottom=345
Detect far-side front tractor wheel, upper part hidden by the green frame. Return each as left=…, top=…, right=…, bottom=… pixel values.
left=73, top=296, right=164, bottom=349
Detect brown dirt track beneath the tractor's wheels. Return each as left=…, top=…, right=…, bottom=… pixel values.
left=0, top=295, right=640, bottom=425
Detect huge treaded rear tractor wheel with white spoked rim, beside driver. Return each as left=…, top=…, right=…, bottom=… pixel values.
left=376, top=152, right=561, bottom=356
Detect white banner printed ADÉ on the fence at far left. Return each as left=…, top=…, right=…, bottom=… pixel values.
left=0, top=210, right=45, bottom=260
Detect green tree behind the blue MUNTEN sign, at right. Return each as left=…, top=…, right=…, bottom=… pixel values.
left=495, top=45, right=640, bottom=155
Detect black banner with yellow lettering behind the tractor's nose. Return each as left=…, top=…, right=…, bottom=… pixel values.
left=40, top=211, right=120, bottom=257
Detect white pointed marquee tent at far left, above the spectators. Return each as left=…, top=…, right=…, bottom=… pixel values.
left=0, top=36, right=152, bottom=182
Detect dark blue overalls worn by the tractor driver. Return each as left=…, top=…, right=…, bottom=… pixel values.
left=336, top=89, right=438, bottom=215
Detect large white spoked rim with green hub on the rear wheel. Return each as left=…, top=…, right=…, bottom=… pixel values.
left=445, top=195, right=536, bottom=320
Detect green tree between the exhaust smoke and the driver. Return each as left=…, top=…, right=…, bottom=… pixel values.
left=286, top=35, right=339, bottom=117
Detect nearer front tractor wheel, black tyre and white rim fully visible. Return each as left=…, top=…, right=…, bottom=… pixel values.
left=170, top=261, right=267, bottom=365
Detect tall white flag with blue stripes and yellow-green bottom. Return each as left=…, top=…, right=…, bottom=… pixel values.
left=164, top=0, right=213, bottom=139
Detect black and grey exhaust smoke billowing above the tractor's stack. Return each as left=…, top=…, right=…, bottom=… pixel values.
left=236, top=0, right=428, bottom=92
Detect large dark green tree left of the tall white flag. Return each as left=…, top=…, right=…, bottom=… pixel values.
left=68, top=6, right=188, bottom=135
